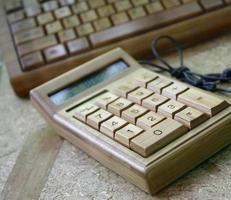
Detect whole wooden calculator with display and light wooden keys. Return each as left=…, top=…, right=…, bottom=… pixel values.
left=30, top=48, right=231, bottom=194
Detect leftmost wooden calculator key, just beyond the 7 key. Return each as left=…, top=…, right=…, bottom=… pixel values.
left=73, top=103, right=99, bottom=122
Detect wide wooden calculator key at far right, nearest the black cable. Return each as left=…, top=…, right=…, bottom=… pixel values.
left=177, top=89, right=229, bottom=116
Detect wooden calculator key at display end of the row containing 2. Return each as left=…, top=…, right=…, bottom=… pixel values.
left=95, top=92, right=119, bottom=110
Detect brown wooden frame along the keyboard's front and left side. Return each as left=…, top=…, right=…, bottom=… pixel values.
left=4, top=6, right=231, bottom=97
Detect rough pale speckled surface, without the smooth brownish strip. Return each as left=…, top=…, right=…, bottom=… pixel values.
left=0, top=35, right=231, bottom=200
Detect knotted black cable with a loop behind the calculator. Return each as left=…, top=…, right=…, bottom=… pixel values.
left=139, top=35, right=231, bottom=93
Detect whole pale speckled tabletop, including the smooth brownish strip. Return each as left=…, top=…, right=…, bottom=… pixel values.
left=0, top=1, right=231, bottom=200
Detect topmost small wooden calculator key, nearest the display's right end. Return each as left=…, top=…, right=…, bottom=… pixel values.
left=134, top=72, right=158, bottom=88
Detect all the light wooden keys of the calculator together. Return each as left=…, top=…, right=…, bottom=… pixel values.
left=67, top=72, right=228, bottom=157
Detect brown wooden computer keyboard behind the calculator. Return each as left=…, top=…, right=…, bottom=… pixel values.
left=5, top=0, right=231, bottom=96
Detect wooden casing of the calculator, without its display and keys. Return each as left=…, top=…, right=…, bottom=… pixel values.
left=30, top=48, right=231, bottom=194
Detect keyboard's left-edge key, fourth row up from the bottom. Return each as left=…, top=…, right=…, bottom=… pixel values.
left=11, top=18, right=36, bottom=33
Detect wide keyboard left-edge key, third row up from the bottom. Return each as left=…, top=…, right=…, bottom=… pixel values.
left=14, top=27, right=44, bottom=44
